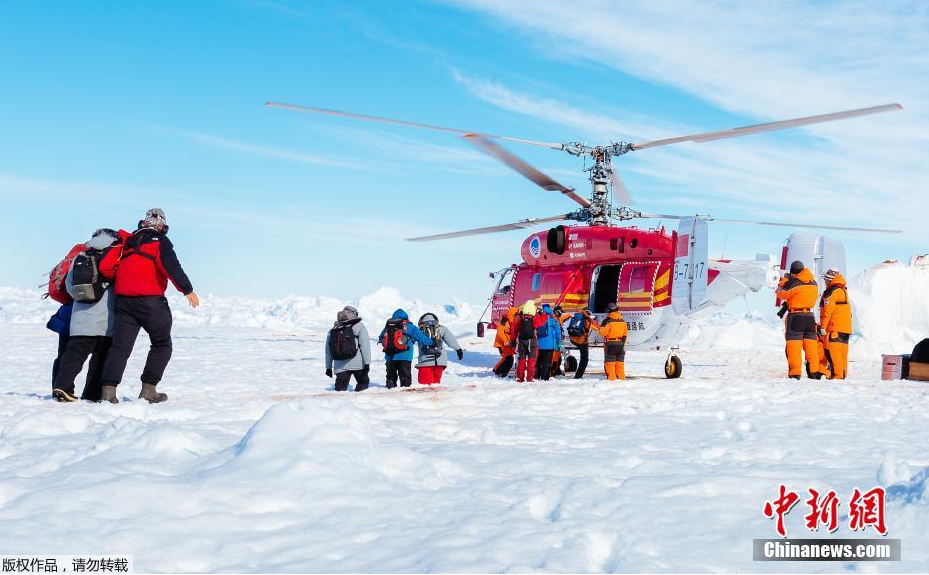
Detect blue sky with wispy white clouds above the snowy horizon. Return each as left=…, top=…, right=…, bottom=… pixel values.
left=0, top=0, right=929, bottom=302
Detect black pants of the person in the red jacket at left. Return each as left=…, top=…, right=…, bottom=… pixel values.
left=103, top=296, right=172, bottom=385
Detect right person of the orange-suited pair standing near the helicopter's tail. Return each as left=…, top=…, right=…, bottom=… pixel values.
left=819, top=269, right=852, bottom=379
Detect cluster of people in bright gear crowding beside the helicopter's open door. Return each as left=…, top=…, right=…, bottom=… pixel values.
left=494, top=300, right=629, bottom=383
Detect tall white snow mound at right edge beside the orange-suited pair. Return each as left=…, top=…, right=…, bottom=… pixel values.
left=848, top=257, right=929, bottom=355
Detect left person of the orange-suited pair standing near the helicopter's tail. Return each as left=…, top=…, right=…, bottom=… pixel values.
left=777, top=260, right=822, bottom=379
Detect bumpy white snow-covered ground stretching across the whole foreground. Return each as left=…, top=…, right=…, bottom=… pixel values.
left=0, top=266, right=929, bottom=572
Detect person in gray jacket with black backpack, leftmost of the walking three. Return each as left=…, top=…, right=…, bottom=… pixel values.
left=326, top=305, right=371, bottom=391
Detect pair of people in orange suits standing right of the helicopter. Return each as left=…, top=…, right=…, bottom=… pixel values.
left=777, top=260, right=852, bottom=379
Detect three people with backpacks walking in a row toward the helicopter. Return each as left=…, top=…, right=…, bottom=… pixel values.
left=325, top=306, right=464, bottom=391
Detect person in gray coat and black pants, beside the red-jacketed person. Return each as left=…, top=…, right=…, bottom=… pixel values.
left=52, top=228, right=118, bottom=402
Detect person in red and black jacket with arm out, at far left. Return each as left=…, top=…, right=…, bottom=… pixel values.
left=100, top=208, right=200, bottom=403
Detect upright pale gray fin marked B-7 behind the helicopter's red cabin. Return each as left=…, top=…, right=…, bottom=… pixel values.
left=671, top=218, right=708, bottom=315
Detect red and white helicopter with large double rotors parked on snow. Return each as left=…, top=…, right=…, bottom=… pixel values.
left=265, top=101, right=903, bottom=379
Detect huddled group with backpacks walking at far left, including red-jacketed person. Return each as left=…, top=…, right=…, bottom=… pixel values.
left=47, top=208, right=200, bottom=403
